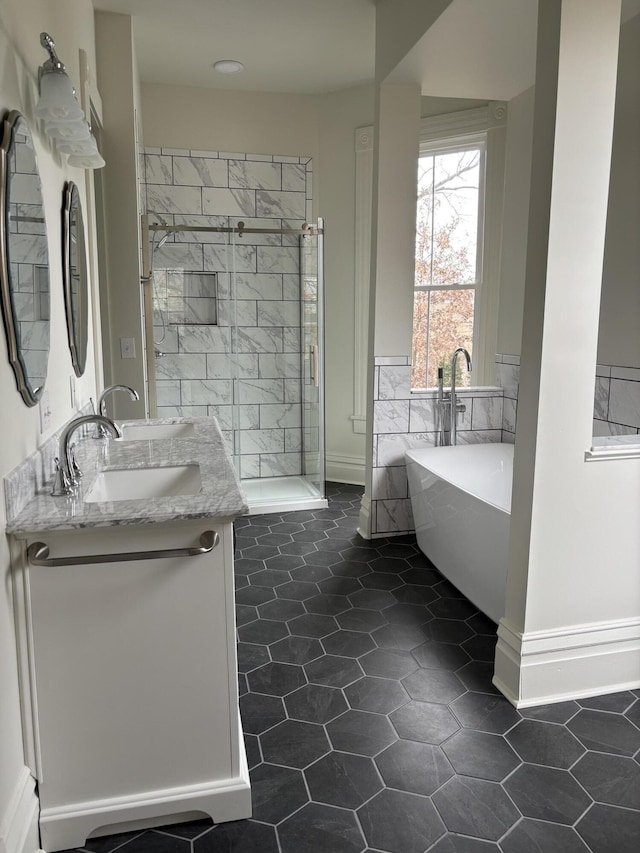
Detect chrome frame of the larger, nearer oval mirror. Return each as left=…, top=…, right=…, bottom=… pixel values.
left=0, top=110, right=48, bottom=407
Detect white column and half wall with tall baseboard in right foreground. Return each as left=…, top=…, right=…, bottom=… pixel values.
left=495, top=0, right=640, bottom=706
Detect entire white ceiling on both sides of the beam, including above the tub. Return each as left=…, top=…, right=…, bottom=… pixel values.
left=93, top=0, right=640, bottom=100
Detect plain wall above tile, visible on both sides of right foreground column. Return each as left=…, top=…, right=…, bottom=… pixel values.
left=498, top=16, right=640, bottom=367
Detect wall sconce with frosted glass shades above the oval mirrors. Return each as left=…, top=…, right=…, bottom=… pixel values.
left=36, top=33, right=105, bottom=169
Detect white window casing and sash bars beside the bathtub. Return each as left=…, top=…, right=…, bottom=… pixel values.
left=412, top=101, right=507, bottom=391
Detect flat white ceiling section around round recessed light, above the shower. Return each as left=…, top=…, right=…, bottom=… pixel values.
left=93, top=0, right=375, bottom=94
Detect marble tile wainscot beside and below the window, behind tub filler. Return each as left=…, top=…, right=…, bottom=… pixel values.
left=371, top=356, right=503, bottom=538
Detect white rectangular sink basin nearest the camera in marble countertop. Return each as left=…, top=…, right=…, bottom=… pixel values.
left=85, top=465, right=202, bottom=503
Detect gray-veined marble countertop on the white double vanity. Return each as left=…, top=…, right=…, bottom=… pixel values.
left=6, top=418, right=248, bottom=534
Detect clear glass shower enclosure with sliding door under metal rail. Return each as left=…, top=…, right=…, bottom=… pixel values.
left=145, top=216, right=326, bottom=512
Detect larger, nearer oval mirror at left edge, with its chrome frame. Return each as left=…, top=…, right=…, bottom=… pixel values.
left=0, top=110, right=49, bottom=406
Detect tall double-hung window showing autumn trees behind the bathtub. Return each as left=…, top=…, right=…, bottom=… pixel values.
left=411, top=134, right=486, bottom=388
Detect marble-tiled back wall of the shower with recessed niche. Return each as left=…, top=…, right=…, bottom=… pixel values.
left=144, top=148, right=312, bottom=477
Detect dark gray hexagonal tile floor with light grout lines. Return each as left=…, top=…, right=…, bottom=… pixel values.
left=61, top=484, right=640, bottom=853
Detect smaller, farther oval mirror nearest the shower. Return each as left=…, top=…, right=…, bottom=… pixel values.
left=62, top=181, right=88, bottom=376
